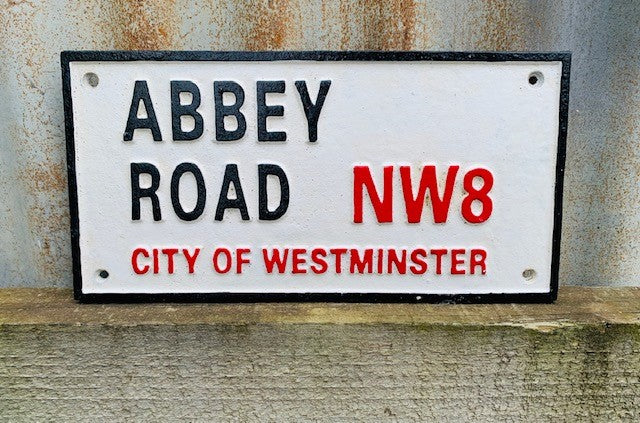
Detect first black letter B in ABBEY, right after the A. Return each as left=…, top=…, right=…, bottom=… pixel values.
left=171, top=81, right=204, bottom=141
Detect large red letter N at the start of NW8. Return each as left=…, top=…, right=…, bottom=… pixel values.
left=353, top=166, right=393, bottom=223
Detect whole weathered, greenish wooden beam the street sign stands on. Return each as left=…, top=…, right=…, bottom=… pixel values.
left=0, top=287, right=640, bottom=422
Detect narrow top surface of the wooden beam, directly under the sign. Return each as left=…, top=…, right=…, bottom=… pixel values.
left=0, top=286, right=640, bottom=330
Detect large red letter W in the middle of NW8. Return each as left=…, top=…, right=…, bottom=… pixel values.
left=400, top=165, right=460, bottom=223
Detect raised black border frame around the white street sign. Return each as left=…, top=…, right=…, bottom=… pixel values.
left=60, top=51, right=571, bottom=304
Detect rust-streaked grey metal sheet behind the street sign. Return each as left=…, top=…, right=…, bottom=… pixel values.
left=0, top=0, right=640, bottom=287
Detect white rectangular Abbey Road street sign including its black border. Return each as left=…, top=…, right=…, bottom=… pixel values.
left=62, top=52, right=570, bottom=302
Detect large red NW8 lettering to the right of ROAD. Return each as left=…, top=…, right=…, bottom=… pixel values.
left=353, top=165, right=493, bottom=223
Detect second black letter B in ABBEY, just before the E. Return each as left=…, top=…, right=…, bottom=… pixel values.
left=213, top=81, right=247, bottom=141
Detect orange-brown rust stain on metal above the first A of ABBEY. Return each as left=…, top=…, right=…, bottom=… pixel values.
left=108, top=0, right=178, bottom=50
